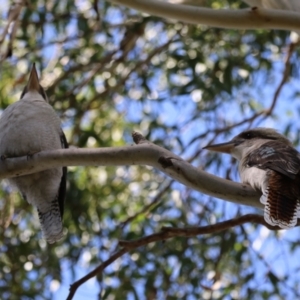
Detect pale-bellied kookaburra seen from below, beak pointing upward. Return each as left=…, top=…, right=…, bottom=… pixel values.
left=0, top=65, right=68, bottom=243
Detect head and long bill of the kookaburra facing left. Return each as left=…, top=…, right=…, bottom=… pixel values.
left=203, top=128, right=292, bottom=160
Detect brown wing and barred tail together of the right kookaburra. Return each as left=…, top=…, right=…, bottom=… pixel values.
left=247, top=141, right=300, bottom=228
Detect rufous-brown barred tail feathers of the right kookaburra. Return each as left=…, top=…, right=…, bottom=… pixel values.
left=260, top=170, right=300, bottom=229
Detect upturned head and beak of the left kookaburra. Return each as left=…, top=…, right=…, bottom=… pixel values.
left=21, top=63, right=49, bottom=102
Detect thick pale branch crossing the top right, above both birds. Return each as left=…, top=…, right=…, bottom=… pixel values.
left=108, top=0, right=300, bottom=30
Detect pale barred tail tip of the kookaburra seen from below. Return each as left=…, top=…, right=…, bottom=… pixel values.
left=38, top=200, right=63, bottom=244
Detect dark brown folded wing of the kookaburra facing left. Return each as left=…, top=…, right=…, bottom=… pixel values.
left=245, top=141, right=300, bottom=179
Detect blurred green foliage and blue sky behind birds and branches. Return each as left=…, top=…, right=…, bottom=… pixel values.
left=0, top=0, right=300, bottom=300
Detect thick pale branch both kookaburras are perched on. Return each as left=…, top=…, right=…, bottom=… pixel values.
left=0, top=132, right=263, bottom=208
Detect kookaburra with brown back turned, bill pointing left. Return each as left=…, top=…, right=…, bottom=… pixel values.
left=204, top=128, right=300, bottom=228
